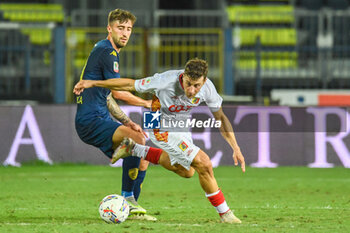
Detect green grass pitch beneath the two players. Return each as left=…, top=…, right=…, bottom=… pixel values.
left=0, top=164, right=350, bottom=233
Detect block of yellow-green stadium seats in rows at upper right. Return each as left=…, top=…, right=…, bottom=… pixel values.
left=227, top=1, right=298, bottom=70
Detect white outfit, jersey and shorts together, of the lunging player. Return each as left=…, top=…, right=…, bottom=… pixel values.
left=135, top=70, right=222, bottom=170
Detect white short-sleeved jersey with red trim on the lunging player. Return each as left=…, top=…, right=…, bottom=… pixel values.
left=135, top=70, right=222, bottom=116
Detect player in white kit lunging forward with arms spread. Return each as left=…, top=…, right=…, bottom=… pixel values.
left=73, top=58, right=245, bottom=223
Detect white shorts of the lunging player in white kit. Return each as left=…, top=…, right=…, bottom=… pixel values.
left=149, top=132, right=200, bottom=170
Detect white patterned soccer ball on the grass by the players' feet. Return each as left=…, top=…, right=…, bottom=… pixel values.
left=98, top=194, right=130, bottom=223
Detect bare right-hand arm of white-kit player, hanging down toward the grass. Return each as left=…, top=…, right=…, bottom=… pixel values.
left=213, top=108, right=245, bottom=172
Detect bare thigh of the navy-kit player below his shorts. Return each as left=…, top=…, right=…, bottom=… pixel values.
left=112, top=125, right=146, bottom=149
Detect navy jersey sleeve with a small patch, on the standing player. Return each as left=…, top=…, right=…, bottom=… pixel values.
left=99, top=49, right=120, bottom=79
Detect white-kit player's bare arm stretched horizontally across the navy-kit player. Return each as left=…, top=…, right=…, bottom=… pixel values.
left=73, top=78, right=135, bottom=95
